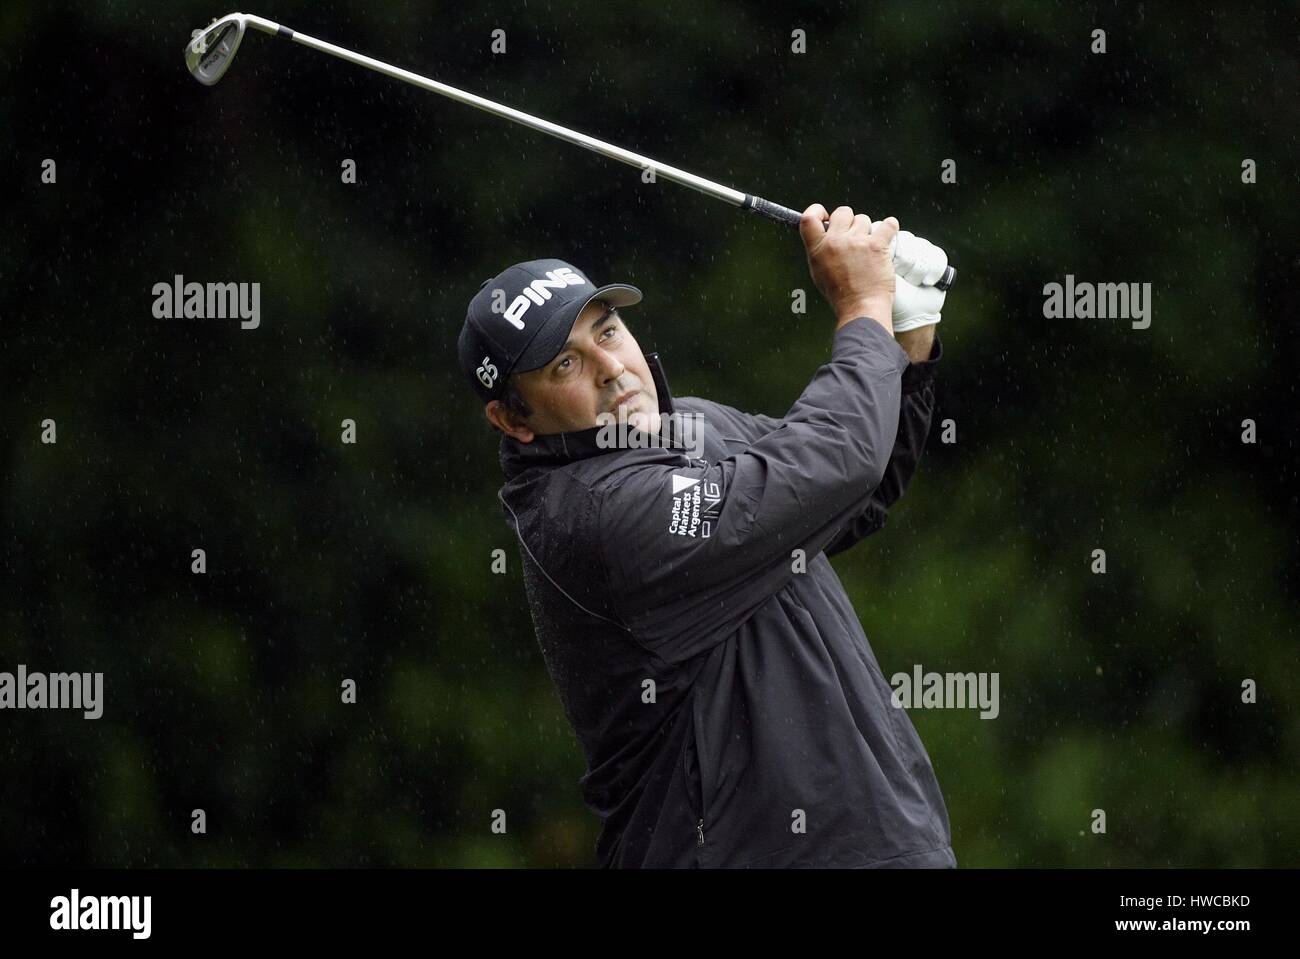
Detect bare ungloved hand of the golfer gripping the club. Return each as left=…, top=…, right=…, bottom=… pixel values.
left=800, top=203, right=898, bottom=334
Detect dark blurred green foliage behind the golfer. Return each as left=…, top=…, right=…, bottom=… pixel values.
left=0, top=0, right=1300, bottom=867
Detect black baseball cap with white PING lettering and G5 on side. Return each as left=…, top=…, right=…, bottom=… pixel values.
left=456, top=260, right=641, bottom=403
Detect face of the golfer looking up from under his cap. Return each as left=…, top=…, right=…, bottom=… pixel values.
left=486, top=300, right=659, bottom=443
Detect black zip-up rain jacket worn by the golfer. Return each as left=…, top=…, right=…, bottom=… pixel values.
left=499, top=318, right=956, bottom=867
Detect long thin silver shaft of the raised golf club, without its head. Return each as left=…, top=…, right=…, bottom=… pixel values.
left=247, top=14, right=956, bottom=290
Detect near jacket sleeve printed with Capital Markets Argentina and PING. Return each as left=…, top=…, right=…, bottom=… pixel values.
left=597, top=318, right=909, bottom=663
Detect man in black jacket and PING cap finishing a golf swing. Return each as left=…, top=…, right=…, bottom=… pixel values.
left=459, top=204, right=957, bottom=868
